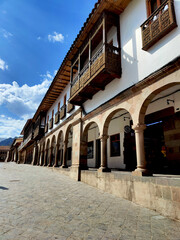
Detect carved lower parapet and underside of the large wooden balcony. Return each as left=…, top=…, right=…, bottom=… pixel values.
left=69, top=44, right=121, bottom=105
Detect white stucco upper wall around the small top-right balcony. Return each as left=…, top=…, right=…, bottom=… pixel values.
left=84, top=0, right=180, bottom=112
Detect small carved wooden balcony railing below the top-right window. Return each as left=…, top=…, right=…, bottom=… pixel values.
left=141, top=0, right=177, bottom=50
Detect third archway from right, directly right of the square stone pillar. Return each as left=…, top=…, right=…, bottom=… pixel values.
left=81, top=121, right=101, bottom=168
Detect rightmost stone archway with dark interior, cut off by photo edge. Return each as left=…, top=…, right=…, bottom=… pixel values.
left=137, top=82, right=180, bottom=174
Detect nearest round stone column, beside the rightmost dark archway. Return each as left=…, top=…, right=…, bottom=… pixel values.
left=132, top=124, right=151, bottom=176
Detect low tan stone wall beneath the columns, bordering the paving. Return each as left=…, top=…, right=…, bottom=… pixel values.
left=81, top=170, right=180, bottom=220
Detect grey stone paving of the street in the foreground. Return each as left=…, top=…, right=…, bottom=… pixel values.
left=0, top=163, right=180, bottom=240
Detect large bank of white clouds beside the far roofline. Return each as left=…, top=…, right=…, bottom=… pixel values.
left=0, top=71, right=56, bottom=119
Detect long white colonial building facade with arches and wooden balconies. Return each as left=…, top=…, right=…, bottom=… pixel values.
left=15, top=0, right=180, bottom=219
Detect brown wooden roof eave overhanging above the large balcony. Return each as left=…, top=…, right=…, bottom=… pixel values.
left=33, top=0, right=131, bottom=121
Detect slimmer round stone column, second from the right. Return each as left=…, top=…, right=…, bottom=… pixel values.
left=98, top=135, right=110, bottom=172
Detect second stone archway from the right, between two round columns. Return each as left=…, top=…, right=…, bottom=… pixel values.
left=102, top=108, right=137, bottom=171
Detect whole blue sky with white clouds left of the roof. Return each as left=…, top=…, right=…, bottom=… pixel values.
left=0, top=0, right=97, bottom=138
